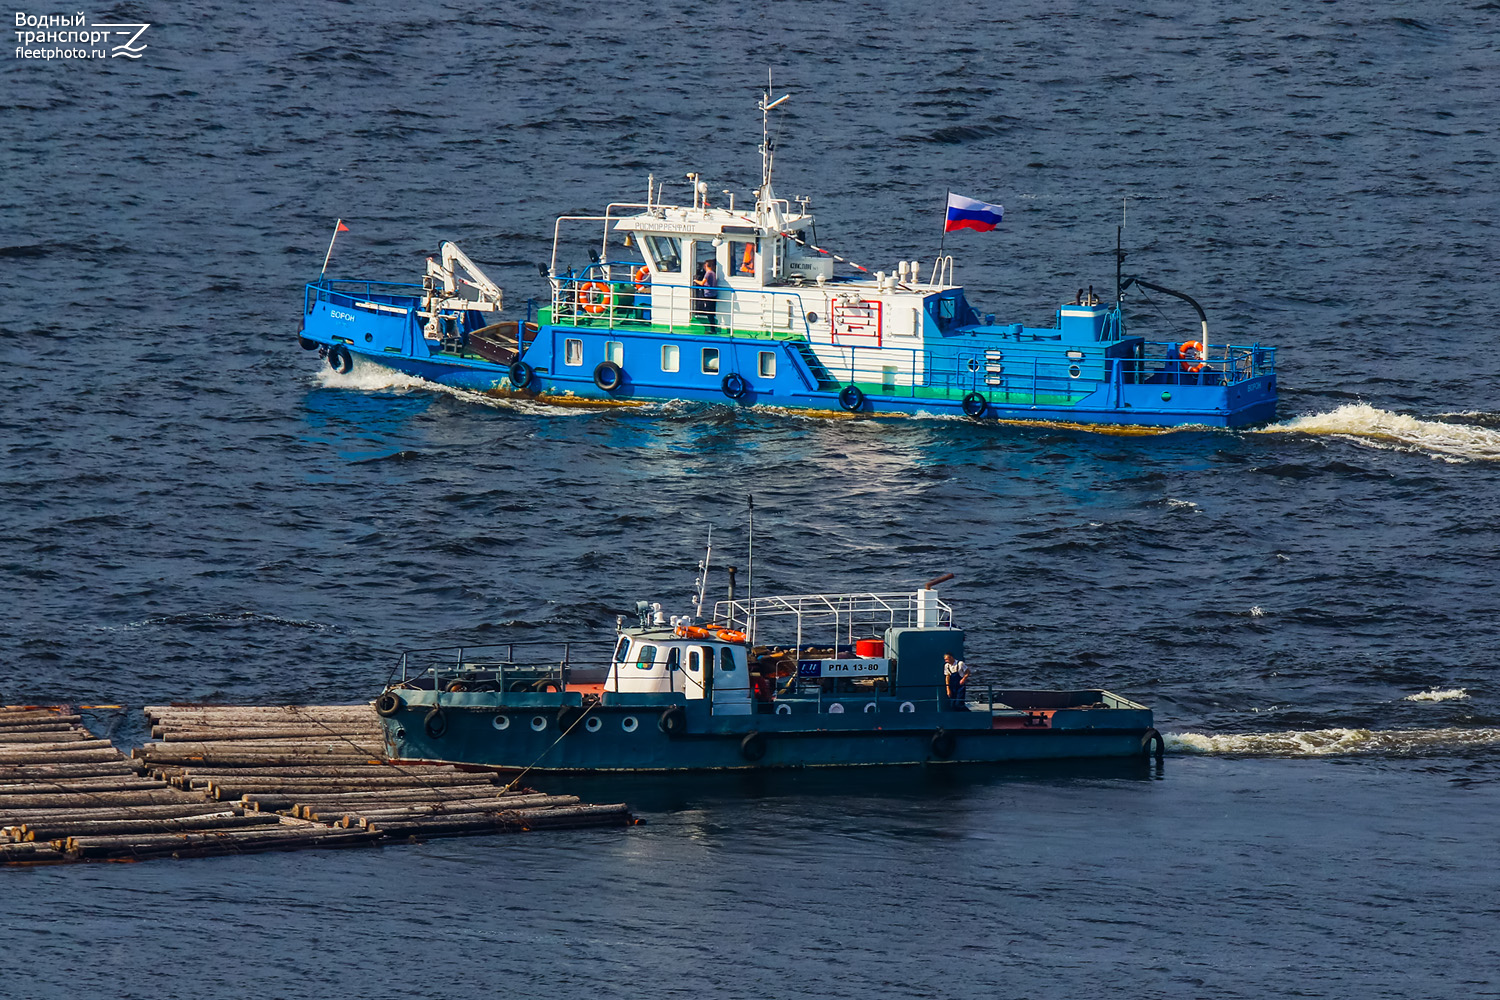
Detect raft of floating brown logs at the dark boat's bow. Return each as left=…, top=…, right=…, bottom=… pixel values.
left=0, top=705, right=633, bottom=865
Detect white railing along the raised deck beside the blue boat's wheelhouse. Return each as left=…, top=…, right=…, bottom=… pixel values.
left=552, top=261, right=812, bottom=340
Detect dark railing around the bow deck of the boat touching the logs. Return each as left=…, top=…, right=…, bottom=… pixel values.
left=387, top=640, right=612, bottom=691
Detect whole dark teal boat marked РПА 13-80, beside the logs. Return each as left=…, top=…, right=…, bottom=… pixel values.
left=375, top=575, right=1161, bottom=772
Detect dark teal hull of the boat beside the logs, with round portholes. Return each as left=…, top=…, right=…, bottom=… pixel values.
left=386, top=691, right=1161, bottom=772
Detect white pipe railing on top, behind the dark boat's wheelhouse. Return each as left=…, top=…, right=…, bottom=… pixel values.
left=714, top=591, right=953, bottom=649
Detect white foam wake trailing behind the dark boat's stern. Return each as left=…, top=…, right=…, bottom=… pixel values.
left=1163, top=729, right=1500, bottom=757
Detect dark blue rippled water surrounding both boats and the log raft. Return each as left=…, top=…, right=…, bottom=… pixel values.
left=0, top=1, right=1500, bottom=997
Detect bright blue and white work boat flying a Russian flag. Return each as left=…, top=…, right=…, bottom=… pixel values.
left=300, top=88, right=1277, bottom=427
